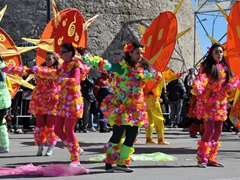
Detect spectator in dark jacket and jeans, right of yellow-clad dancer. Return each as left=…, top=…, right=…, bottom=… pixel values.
left=167, top=79, right=186, bottom=128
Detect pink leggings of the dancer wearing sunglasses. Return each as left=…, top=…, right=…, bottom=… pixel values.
left=54, top=116, right=77, bottom=142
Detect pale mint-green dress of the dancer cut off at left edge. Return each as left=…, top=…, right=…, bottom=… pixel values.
left=0, top=61, right=11, bottom=110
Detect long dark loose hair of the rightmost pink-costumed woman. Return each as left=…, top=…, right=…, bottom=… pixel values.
left=201, top=44, right=233, bottom=83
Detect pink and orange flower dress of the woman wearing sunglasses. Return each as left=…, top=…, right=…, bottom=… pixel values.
left=33, top=59, right=89, bottom=119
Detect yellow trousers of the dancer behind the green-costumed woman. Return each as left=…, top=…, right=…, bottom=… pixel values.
left=146, top=95, right=164, bottom=141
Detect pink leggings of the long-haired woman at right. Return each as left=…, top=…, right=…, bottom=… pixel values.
left=202, top=120, right=223, bottom=142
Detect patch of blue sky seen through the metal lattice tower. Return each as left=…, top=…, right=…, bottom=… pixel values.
left=192, top=0, right=229, bottom=54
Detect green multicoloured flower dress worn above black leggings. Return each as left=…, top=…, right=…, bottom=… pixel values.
left=99, top=60, right=161, bottom=127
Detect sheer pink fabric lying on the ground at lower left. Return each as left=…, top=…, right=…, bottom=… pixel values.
left=0, top=164, right=89, bottom=177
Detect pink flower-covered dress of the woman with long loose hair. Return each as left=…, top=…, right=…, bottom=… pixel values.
left=192, top=64, right=239, bottom=121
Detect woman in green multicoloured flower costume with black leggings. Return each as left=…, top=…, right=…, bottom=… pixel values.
left=99, top=42, right=161, bottom=172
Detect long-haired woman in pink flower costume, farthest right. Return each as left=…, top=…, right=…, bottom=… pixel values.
left=192, top=44, right=238, bottom=168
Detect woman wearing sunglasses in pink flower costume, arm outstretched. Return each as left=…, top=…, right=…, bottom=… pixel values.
left=29, top=43, right=89, bottom=166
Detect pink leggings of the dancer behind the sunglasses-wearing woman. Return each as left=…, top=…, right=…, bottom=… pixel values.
left=36, top=114, right=56, bottom=128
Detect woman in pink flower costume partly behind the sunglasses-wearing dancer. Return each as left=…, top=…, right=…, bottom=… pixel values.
left=27, top=51, right=59, bottom=156
